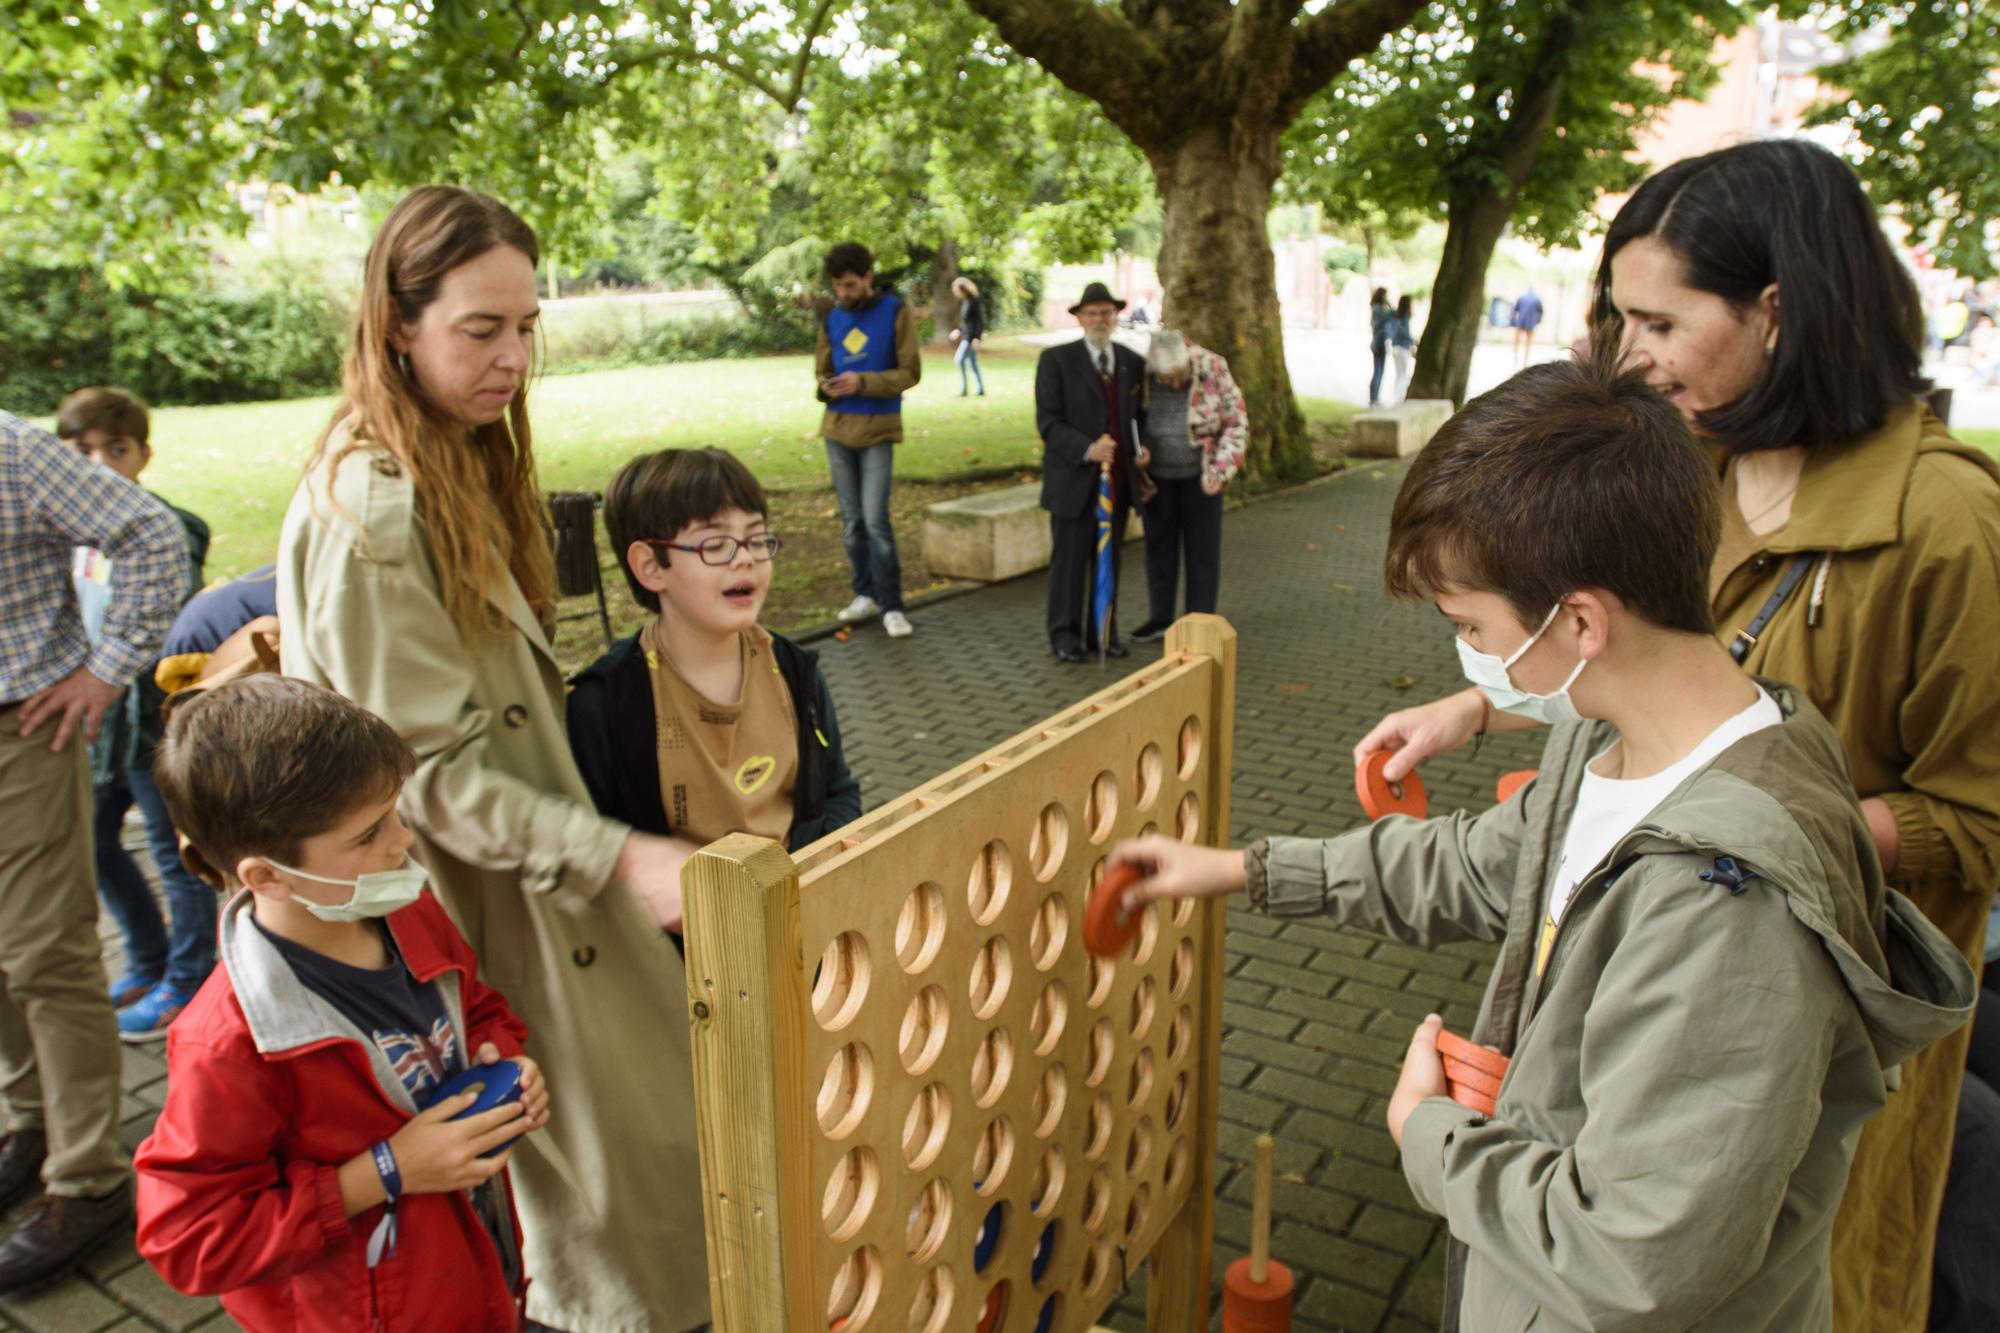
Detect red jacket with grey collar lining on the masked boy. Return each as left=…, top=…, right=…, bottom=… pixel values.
left=134, top=893, right=528, bottom=1333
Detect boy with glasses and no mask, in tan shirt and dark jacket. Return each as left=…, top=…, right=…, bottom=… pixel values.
left=570, top=448, right=862, bottom=849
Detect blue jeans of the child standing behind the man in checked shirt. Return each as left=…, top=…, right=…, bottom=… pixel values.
left=94, top=767, right=218, bottom=993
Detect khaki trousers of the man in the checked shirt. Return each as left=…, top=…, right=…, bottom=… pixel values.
left=0, top=707, right=128, bottom=1195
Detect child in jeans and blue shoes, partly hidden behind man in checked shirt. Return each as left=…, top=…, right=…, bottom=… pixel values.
left=56, top=386, right=216, bottom=1041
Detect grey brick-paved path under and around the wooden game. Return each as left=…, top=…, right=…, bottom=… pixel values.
left=23, top=464, right=1536, bottom=1333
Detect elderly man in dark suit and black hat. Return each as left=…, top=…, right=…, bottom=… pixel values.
left=1034, top=282, right=1146, bottom=662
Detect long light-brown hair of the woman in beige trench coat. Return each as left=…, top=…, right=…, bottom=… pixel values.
left=306, top=186, right=556, bottom=640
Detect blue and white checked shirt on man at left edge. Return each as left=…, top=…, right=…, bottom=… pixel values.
left=0, top=412, right=188, bottom=705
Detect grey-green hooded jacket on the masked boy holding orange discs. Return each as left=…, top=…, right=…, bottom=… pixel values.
left=1250, top=683, right=1974, bottom=1333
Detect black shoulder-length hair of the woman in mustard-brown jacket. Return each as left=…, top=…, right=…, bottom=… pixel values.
left=1594, top=138, right=1930, bottom=452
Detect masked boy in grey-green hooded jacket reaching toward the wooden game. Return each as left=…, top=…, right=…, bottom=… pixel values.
left=1112, top=362, right=1974, bottom=1333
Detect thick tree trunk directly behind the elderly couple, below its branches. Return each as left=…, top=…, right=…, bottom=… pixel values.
left=1146, top=122, right=1312, bottom=478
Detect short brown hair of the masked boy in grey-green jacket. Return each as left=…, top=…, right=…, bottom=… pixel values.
left=1382, top=346, right=1722, bottom=634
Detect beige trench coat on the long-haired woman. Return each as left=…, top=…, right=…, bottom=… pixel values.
left=278, top=450, right=708, bottom=1333
